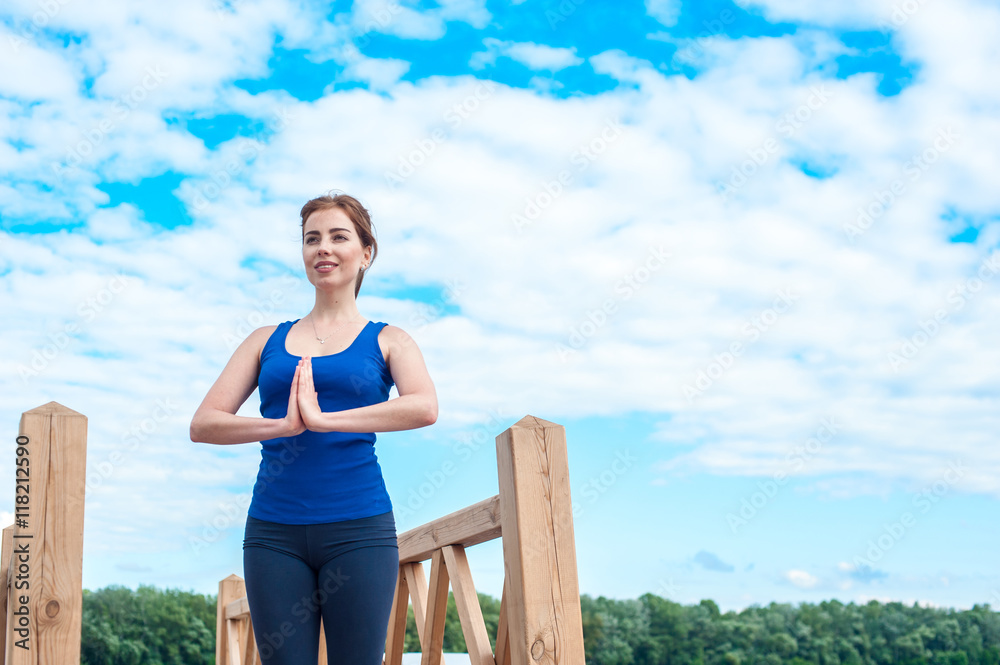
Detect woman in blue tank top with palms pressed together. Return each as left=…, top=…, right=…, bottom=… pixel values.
left=191, top=194, right=437, bottom=665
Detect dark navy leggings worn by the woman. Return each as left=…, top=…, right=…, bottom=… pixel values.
left=243, top=511, right=399, bottom=665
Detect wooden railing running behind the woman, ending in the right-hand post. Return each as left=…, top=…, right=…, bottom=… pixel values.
left=215, top=416, right=584, bottom=665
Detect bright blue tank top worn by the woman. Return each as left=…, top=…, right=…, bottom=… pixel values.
left=248, top=319, right=393, bottom=524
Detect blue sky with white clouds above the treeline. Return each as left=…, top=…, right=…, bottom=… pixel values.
left=0, top=0, right=1000, bottom=610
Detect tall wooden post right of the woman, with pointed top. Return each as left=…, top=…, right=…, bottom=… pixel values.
left=497, top=416, right=584, bottom=665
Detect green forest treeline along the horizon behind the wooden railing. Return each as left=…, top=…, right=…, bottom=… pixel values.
left=81, top=586, right=1000, bottom=665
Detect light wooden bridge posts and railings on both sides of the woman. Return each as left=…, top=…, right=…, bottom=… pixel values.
left=0, top=402, right=584, bottom=665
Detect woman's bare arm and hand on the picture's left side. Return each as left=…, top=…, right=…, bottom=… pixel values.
left=191, top=326, right=305, bottom=444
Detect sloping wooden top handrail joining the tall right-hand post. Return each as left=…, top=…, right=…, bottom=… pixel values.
left=397, top=495, right=501, bottom=563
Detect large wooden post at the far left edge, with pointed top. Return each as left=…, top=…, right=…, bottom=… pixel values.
left=6, top=402, right=87, bottom=665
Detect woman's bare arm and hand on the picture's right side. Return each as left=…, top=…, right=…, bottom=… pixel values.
left=299, top=326, right=437, bottom=432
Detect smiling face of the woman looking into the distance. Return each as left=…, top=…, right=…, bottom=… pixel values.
left=302, top=208, right=371, bottom=293
